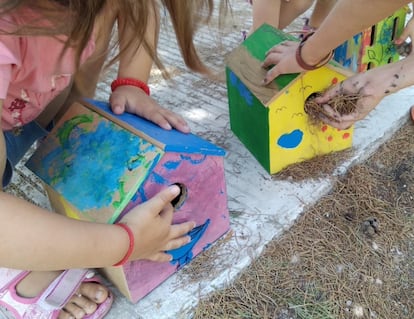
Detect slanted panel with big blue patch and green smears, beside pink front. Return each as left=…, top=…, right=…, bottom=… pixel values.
left=26, top=103, right=163, bottom=223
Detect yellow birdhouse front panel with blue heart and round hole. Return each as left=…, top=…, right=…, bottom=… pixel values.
left=269, top=68, right=353, bottom=172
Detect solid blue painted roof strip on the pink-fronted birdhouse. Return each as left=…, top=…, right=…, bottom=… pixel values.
left=85, top=99, right=226, bottom=156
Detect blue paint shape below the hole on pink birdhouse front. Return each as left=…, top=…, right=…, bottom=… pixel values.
left=166, top=219, right=210, bottom=268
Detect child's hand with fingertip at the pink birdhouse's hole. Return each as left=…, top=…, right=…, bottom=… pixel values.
left=121, top=186, right=196, bottom=262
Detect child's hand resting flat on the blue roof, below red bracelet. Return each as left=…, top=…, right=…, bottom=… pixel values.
left=109, top=86, right=190, bottom=133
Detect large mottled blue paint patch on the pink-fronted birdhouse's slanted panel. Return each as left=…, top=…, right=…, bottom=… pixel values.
left=42, top=121, right=150, bottom=211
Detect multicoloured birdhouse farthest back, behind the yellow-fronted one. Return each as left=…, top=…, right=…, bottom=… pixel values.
left=334, top=6, right=409, bottom=72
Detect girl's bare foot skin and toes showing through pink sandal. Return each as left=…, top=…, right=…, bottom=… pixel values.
left=16, top=272, right=109, bottom=319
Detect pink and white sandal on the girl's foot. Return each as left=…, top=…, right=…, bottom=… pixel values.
left=0, top=268, right=113, bottom=319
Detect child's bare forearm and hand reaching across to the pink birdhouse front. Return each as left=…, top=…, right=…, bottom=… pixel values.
left=0, top=112, right=195, bottom=271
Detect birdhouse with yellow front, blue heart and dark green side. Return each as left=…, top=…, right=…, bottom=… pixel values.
left=226, top=24, right=353, bottom=174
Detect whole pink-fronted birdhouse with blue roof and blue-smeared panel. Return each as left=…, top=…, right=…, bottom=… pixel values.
left=26, top=100, right=229, bottom=302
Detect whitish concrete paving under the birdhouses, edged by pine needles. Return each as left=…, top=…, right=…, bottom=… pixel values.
left=1, top=0, right=414, bottom=319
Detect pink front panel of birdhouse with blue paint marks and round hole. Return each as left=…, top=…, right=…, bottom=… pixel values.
left=103, top=153, right=229, bottom=302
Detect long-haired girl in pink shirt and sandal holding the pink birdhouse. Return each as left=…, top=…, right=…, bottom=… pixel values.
left=0, top=0, right=226, bottom=319
